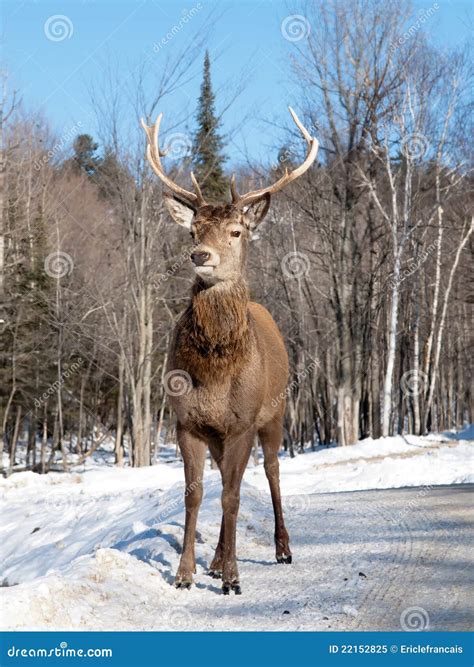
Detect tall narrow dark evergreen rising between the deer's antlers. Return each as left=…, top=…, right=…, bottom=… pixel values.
left=193, top=51, right=229, bottom=202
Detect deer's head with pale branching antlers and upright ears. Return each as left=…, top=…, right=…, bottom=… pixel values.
left=142, top=107, right=319, bottom=284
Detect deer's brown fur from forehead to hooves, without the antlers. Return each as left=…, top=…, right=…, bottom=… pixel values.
left=168, top=199, right=291, bottom=592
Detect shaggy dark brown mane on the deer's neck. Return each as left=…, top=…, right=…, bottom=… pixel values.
left=179, top=279, right=251, bottom=379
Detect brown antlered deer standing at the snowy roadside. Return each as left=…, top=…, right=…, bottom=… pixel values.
left=141, top=107, right=319, bottom=595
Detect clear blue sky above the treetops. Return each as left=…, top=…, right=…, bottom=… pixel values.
left=2, top=0, right=472, bottom=163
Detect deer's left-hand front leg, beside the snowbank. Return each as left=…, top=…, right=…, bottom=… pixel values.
left=175, top=425, right=206, bottom=588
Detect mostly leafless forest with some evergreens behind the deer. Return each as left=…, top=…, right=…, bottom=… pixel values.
left=0, top=0, right=474, bottom=475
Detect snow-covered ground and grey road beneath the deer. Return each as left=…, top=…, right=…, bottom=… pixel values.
left=0, top=439, right=473, bottom=630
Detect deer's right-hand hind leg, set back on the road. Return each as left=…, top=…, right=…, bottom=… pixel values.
left=258, top=416, right=292, bottom=563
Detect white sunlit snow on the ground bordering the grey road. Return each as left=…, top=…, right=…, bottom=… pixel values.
left=0, top=428, right=474, bottom=630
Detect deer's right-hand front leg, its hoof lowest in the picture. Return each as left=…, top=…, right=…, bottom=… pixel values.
left=221, top=429, right=255, bottom=595
